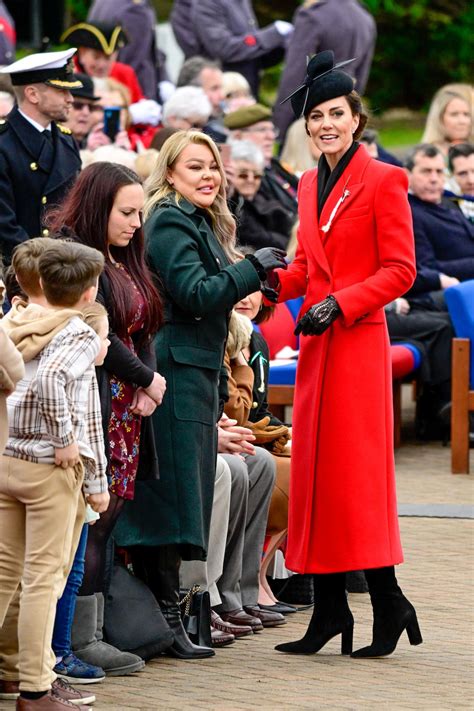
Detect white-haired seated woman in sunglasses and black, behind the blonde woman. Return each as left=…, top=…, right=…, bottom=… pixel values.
left=230, top=141, right=293, bottom=249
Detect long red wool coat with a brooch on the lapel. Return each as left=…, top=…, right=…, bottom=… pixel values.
left=278, top=148, right=415, bottom=573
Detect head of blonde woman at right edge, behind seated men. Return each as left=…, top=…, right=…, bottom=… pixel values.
left=421, top=84, right=474, bottom=156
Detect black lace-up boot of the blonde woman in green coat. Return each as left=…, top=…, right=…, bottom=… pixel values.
left=132, top=545, right=215, bottom=659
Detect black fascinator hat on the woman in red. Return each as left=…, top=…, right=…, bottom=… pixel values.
left=281, top=49, right=354, bottom=118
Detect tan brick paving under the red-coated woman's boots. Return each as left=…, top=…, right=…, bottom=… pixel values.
left=0, top=444, right=474, bottom=711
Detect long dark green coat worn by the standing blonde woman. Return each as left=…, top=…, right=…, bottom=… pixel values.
left=114, top=199, right=260, bottom=560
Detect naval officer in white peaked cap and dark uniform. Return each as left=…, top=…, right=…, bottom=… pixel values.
left=0, top=49, right=81, bottom=261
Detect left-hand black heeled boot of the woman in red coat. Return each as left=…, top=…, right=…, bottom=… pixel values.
left=275, top=573, right=354, bottom=654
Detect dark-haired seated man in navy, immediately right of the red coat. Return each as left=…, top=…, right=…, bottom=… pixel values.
left=405, top=144, right=474, bottom=310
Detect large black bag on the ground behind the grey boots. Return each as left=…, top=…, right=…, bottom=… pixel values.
left=104, top=565, right=174, bottom=661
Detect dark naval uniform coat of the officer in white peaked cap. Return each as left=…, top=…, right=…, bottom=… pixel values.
left=0, top=107, right=81, bottom=263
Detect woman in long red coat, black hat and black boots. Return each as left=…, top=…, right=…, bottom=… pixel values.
left=270, top=51, right=421, bottom=657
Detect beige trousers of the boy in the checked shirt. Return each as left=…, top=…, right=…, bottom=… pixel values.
left=0, top=456, right=85, bottom=691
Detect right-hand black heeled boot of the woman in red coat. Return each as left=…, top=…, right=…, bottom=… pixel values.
left=352, top=566, right=423, bottom=659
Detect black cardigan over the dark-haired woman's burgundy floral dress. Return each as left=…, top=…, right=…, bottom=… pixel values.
left=96, top=273, right=159, bottom=480
